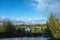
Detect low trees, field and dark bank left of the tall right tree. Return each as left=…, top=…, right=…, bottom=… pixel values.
left=0, top=21, right=46, bottom=38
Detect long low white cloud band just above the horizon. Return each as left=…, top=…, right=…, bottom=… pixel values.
left=0, top=16, right=45, bottom=24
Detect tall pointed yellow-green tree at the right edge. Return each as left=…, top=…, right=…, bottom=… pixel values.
left=46, top=13, right=60, bottom=38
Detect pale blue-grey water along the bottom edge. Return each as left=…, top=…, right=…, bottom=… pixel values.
left=0, top=37, right=49, bottom=40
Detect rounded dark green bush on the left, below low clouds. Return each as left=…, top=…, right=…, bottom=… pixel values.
left=2, top=21, right=15, bottom=33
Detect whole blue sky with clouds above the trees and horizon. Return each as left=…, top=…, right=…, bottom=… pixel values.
left=0, top=0, right=60, bottom=23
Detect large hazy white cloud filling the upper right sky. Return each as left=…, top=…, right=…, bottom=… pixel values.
left=27, top=0, right=60, bottom=13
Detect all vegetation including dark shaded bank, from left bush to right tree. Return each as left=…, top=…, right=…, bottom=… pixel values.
left=0, top=13, right=60, bottom=39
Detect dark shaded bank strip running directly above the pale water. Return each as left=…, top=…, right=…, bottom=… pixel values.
left=0, top=33, right=51, bottom=38
